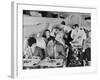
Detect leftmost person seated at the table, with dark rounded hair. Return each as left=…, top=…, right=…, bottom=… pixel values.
left=25, top=37, right=44, bottom=59
